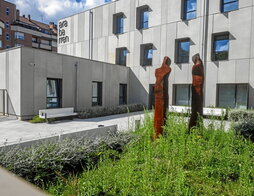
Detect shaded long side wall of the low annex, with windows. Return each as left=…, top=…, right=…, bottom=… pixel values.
left=18, top=47, right=129, bottom=117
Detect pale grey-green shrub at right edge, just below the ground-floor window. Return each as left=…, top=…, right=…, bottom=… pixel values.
left=229, top=109, right=254, bottom=121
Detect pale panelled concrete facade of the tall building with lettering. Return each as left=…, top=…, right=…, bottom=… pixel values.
left=58, top=0, right=254, bottom=107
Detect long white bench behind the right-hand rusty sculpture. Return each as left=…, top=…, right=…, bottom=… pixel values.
left=169, top=106, right=227, bottom=117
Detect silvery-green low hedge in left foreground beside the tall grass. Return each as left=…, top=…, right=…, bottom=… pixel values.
left=0, top=134, right=130, bottom=187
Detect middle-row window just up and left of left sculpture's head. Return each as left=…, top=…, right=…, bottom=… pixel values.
left=140, top=44, right=153, bottom=65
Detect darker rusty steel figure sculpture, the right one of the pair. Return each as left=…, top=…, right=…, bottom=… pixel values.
left=189, top=54, right=204, bottom=131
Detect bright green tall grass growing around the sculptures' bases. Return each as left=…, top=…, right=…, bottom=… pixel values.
left=48, top=116, right=254, bottom=196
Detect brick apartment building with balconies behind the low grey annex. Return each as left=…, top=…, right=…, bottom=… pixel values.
left=0, top=0, right=57, bottom=51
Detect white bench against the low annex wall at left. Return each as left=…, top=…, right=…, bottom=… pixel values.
left=39, top=108, right=78, bottom=120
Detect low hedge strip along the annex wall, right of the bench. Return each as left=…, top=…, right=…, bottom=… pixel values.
left=79, top=104, right=144, bottom=119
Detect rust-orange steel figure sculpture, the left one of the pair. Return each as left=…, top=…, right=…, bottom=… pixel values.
left=153, top=56, right=171, bottom=139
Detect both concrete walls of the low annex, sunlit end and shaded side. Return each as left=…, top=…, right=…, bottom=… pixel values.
left=0, top=47, right=129, bottom=119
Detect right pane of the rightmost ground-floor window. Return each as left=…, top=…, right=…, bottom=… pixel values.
left=236, top=84, right=248, bottom=109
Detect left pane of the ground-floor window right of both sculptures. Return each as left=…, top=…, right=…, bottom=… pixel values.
left=218, top=84, right=236, bottom=108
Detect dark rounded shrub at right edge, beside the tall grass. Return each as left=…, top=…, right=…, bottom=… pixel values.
left=235, top=118, right=254, bottom=142
